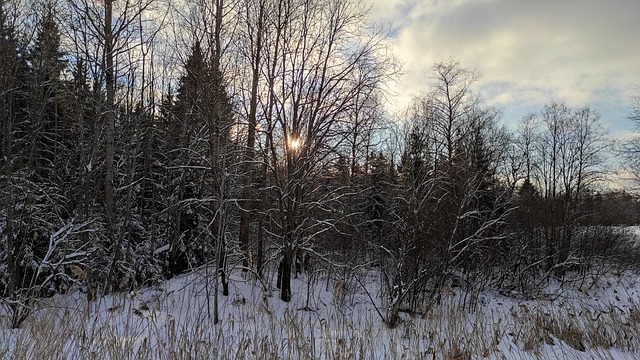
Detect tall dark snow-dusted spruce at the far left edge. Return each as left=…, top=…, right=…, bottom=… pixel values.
left=0, top=2, right=69, bottom=326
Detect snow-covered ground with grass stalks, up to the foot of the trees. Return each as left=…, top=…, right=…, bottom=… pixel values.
left=0, top=270, right=640, bottom=359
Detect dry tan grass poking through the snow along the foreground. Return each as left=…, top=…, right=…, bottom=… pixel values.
left=0, top=272, right=640, bottom=360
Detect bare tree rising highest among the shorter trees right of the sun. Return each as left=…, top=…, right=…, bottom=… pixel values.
left=381, top=59, right=512, bottom=326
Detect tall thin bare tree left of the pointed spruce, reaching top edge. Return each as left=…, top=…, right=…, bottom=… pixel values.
left=67, top=0, right=160, bottom=289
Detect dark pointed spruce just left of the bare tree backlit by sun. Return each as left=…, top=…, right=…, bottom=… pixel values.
left=164, top=41, right=231, bottom=273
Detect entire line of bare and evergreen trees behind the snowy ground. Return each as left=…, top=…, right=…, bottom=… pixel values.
left=0, top=0, right=639, bottom=326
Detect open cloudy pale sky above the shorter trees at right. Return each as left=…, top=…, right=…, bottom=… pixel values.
left=368, top=0, right=640, bottom=134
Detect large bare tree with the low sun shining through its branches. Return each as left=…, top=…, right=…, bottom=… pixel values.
left=255, top=0, right=387, bottom=301
